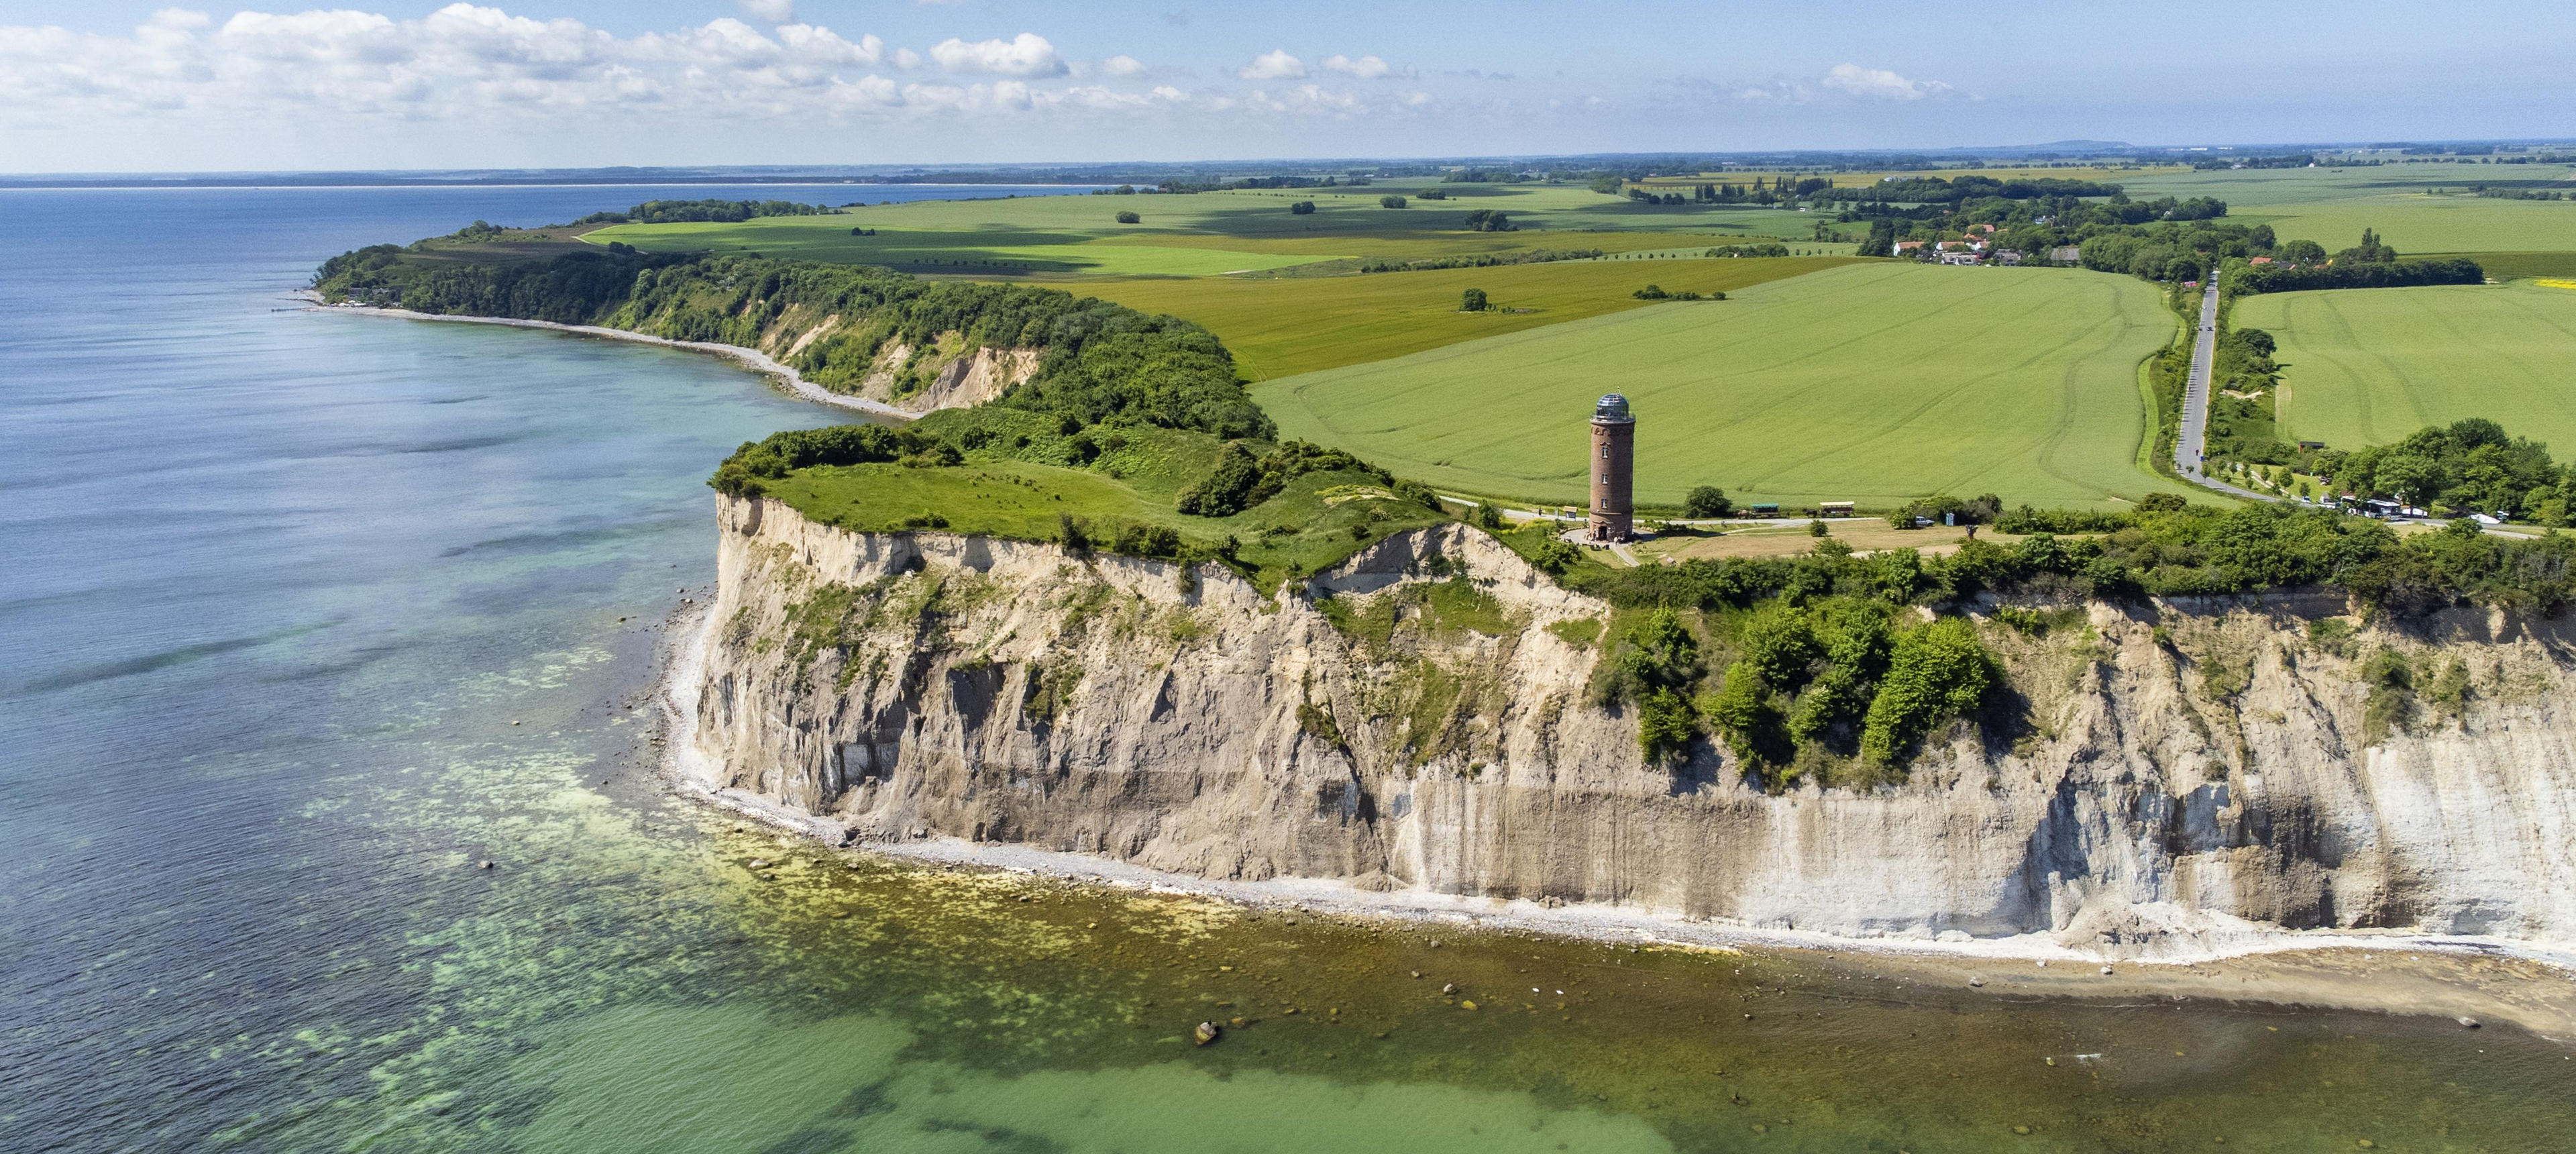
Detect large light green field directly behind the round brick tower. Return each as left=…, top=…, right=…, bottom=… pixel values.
left=1254, top=263, right=2187, bottom=505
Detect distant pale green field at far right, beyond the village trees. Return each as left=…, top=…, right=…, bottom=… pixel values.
left=2120, top=165, right=2576, bottom=255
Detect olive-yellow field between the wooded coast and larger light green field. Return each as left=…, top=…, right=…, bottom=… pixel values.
left=1082, top=258, right=1852, bottom=381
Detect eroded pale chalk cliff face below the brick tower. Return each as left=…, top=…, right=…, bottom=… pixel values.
left=698, top=500, right=2576, bottom=953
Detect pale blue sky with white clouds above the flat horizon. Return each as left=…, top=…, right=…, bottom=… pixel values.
left=0, top=0, right=2576, bottom=172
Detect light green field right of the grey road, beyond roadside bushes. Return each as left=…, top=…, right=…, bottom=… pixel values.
left=2233, top=280, right=2576, bottom=448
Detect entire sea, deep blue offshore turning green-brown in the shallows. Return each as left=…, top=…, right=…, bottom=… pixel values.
left=0, top=185, right=2576, bottom=1154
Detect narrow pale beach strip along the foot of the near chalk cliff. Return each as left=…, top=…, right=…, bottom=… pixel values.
left=654, top=600, right=2576, bottom=1041
